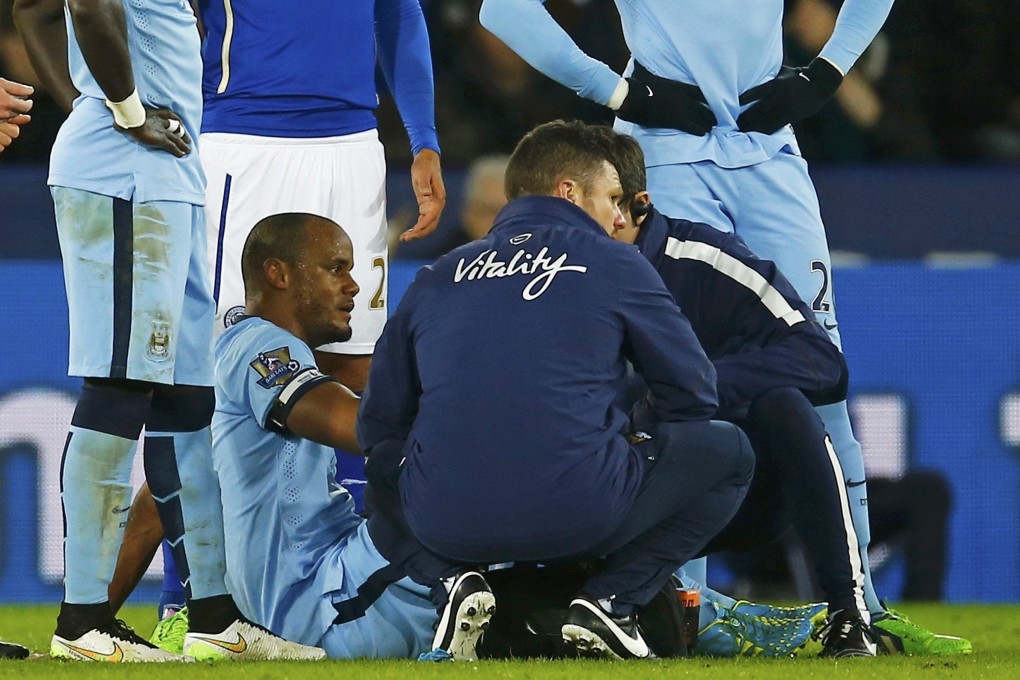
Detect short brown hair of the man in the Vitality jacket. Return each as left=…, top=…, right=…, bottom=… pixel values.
left=503, top=120, right=612, bottom=201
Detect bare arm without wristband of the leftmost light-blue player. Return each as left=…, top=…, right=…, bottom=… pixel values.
left=13, top=0, right=78, bottom=111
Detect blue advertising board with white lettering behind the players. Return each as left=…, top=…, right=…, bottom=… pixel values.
left=0, top=260, right=1020, bottom=603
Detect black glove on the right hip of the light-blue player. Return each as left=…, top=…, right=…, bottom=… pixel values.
left=736, top=57, right=843, bottom=135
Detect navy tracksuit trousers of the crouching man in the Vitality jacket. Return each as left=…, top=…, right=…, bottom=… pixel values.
left=365, top=421, right=754, bottom=614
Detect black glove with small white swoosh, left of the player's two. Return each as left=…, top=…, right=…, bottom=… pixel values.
left=616, top=63, right=716, bottom=137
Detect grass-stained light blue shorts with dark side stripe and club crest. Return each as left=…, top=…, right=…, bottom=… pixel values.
left=51, top=187, right=215, bottom=386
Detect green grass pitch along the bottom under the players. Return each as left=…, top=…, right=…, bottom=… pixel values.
left=0, top=604, right=1020, bottom=680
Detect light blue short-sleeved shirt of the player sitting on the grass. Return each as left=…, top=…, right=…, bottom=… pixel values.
left=212, top=317, right=361, bottom=643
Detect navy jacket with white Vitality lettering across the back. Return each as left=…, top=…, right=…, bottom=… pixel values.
left=358, top=197, right=717, bottom=563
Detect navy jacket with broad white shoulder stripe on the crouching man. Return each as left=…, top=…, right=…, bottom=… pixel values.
left=636, top=209, right=848, bottom=419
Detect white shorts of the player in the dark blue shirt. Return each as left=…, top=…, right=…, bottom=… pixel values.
left=199, top=129, right=388, bottom=355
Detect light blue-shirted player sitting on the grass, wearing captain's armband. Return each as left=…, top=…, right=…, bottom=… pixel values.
left=212, top=213, right=437, bottom=658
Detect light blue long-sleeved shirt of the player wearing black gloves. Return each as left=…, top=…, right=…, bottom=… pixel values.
left=479, top=0, right=893, bottom=167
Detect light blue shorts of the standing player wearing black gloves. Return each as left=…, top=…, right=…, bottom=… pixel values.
left=648, top=151, right=842, bottom=347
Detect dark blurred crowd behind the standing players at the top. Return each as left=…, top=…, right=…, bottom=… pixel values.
left=0, top=0, right=1020, bottom=167
